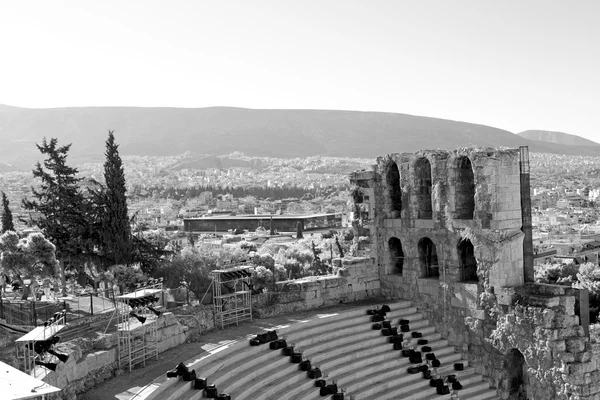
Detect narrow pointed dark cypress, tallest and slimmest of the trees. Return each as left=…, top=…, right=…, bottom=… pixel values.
left=101, top=131, right=133, bottom=264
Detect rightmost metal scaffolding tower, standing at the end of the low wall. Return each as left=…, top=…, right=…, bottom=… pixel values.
left=211, top=265, right=254, bottom=329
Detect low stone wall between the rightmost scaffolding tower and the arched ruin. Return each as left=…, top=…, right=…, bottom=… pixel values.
left=252, top=257, right=381, bottom=318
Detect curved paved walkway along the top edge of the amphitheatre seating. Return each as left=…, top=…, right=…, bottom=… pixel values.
left=77, top=299, right=385, bottom=400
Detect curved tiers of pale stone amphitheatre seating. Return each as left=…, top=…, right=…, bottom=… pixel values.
left=141, top=301, right=498, bottom=400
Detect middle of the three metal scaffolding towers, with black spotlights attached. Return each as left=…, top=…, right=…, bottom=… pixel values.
left=115, top=282, right=163, bottom=372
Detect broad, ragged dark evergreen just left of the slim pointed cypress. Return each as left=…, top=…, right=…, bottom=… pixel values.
left=23, top=138, right=91, bottom=293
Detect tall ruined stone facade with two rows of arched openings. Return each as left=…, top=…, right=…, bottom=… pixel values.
left=350, top=149, right=600, bottom=399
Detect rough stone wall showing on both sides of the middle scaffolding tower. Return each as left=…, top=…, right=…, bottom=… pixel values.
left=42, top=312, right=189, bottom=400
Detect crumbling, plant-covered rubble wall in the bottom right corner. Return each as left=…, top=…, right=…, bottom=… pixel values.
left=486, top=284, right=600, bottom=400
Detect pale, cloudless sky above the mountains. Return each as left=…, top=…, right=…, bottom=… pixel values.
left=0, top=0, right=600, bottom=141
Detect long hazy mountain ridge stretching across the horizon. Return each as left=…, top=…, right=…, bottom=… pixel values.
left=0, top=105, right=600, bottom=171
